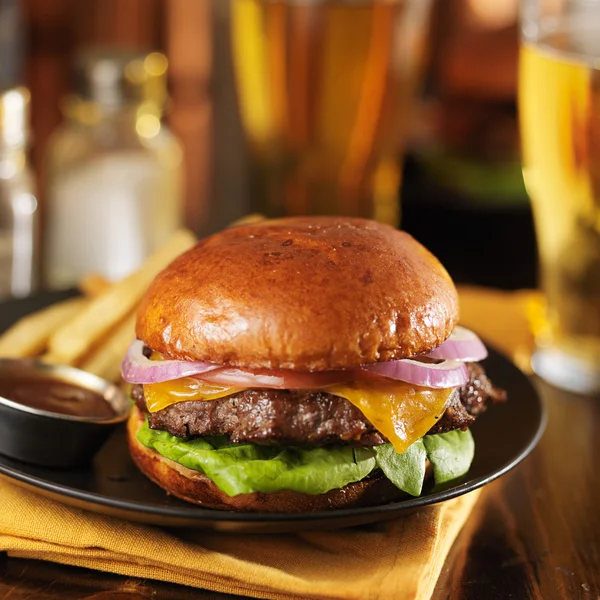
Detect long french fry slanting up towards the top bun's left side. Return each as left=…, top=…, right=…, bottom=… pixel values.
left=48, top=229, right=196, bottom=365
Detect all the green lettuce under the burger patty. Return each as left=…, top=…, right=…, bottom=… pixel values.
left=138, top=422, right=474, bottom=496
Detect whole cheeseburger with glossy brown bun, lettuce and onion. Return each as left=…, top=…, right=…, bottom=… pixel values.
left=123, top=217, right=504, bottom=512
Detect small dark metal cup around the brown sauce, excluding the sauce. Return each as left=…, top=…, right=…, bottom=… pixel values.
left=0, top=359, right=131, bottom=468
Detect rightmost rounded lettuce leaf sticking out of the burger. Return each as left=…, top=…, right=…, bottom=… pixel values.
left=423, top=429, right=475, bottom=485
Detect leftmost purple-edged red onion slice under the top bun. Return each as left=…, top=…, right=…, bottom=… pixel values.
left=121, top=340, right=219, bottom=383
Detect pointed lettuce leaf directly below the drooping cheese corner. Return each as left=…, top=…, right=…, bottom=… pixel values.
left=373, top=440, right=427, bottom=496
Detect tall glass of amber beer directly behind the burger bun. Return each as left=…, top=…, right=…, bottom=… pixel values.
left=230, top=0, right=431, bottom=224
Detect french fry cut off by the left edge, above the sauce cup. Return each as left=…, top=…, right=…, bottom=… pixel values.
left=0, top=298, right=89, bottom=358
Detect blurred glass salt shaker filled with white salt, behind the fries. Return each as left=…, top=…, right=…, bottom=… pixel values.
left=44, top=50, right=182, bottom=289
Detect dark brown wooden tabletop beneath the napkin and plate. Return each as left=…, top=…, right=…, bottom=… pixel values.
left=0, top=382, right=600, bottom=600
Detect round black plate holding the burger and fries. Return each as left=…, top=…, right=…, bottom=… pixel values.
left=0, top=296, right=546, bottom=532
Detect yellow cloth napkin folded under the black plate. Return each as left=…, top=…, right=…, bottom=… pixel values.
left=0, top=288, right=531, bottom=600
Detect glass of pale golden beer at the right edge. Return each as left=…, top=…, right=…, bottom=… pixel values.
left=519, top=0, right=600, bottom=393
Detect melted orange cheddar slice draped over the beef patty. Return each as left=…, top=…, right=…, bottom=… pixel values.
left=144, top=377, right=453, bottom=453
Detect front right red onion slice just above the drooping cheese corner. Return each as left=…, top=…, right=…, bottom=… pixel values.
left=362, top=358, right=469, bottom=388
